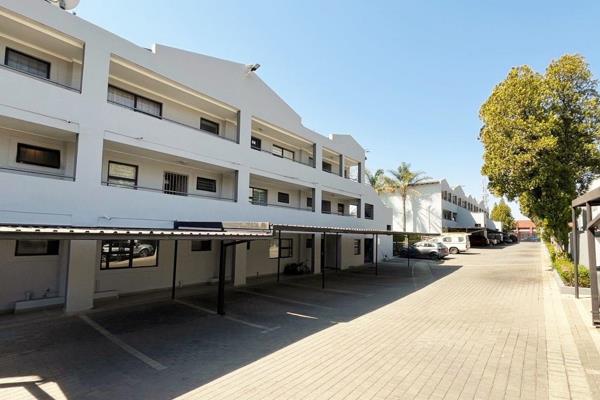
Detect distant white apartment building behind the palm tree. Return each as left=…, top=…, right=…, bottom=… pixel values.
left=380, top=179, right=501, bottom=233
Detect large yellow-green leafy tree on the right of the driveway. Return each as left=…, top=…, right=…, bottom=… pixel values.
left=479, top=55, right=600, bottom=248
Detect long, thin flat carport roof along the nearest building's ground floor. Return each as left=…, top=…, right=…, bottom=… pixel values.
left=0, top=225, right=273, bottom=240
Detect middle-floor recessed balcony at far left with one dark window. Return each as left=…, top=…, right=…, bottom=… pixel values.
left=0, top=116, right=77, bottom=181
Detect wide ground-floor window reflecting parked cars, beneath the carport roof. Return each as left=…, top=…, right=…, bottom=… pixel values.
left=100, top=240, right=158, bottom=269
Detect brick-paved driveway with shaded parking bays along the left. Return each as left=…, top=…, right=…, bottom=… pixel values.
left=0, top=243, right=600, bottom=399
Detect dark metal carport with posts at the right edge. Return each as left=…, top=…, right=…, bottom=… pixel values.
left=571, top=187, right=600, bottom=326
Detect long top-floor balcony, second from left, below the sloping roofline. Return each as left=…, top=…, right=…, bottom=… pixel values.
left=107, top=55, right=239, bottom=142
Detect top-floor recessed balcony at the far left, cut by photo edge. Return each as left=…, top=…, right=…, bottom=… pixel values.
left=0, top=9, right=84, bottom=92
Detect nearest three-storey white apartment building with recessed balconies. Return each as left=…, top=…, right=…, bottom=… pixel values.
left=0, top=0, right=392, bottom=312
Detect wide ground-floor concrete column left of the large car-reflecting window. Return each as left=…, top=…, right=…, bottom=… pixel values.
left=65, top=240, right=97, bottom=313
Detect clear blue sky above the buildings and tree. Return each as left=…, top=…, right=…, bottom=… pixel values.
left=71, top=0, right=600, bottom=219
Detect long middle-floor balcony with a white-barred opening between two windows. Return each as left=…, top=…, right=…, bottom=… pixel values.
left=102, top=140, right=237, bottom=201
